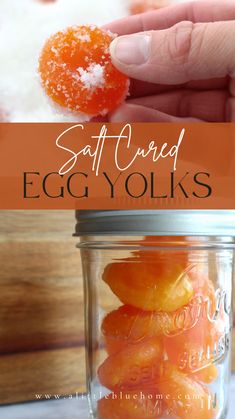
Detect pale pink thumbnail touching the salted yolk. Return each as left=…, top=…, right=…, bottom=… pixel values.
left=110, top=34, right=151, bottom=65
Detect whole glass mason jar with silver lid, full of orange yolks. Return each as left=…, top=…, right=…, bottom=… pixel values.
left=76, top=211, right=235, bottom=419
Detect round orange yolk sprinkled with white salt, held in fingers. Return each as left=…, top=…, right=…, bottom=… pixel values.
left=39, top=26, right=129, bottom=116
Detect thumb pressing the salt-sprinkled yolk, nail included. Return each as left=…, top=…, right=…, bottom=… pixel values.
left=110, top=21, right=235, bottom=84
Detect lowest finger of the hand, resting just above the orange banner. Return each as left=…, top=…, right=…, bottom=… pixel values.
left=109, top=104, right=202, bottom=123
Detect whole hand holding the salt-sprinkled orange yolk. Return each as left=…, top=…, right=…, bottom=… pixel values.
left=106, top=0, right=235, bottom=122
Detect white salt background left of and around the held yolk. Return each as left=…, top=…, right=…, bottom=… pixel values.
left=0, top=0, right=127, bottom=122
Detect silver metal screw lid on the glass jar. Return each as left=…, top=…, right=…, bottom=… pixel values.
left=75, top=210, right=235, bottom=237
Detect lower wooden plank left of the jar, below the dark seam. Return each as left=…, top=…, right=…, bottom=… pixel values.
left=0, top=347, right=86, bottom=404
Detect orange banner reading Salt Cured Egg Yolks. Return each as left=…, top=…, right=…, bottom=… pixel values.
left=0, top=123, right=235, bottom=209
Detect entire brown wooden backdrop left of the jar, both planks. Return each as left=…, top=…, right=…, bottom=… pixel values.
left=0, top=211, right=235, bottom=404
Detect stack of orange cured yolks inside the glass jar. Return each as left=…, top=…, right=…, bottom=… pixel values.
left=98, top=237, right=220, bottom=419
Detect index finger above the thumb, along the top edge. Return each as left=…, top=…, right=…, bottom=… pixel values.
left=105, top=0, right=235, bottom=35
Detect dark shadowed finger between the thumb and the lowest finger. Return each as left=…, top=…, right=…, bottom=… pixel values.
left=128, top=90, right=229, bottom=122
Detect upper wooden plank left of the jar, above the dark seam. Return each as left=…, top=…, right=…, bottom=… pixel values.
left=0, top=211, right=84, bottom=354
